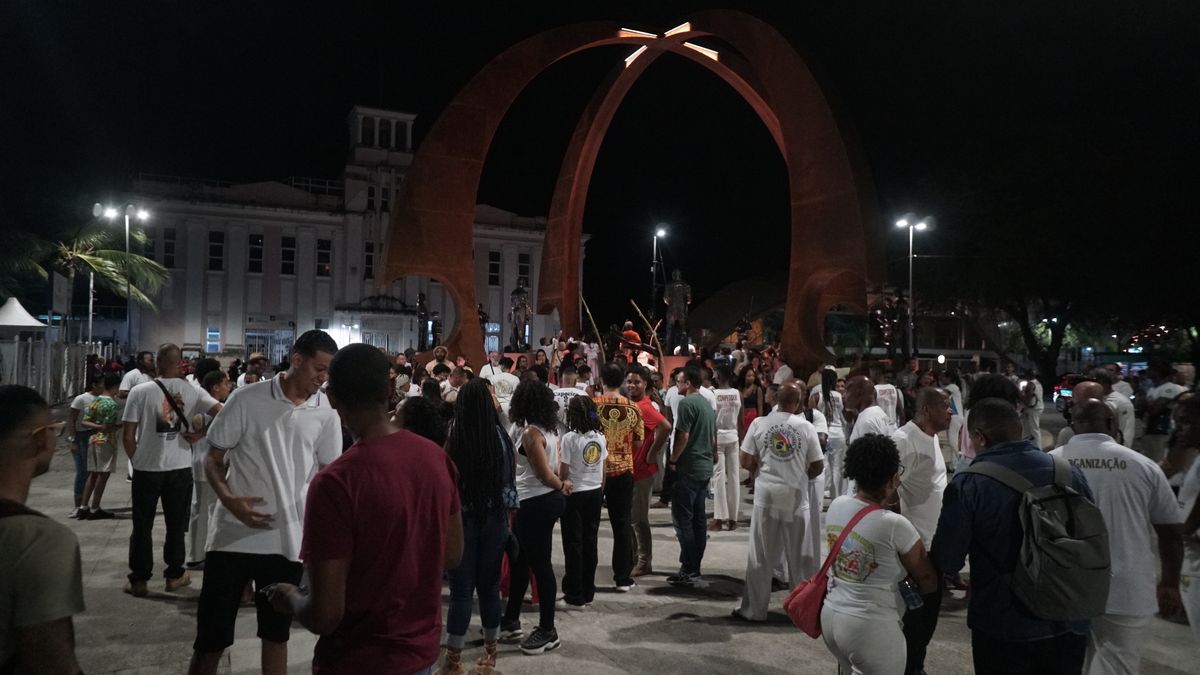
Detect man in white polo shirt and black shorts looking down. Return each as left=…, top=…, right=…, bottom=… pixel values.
left=188, top=330, right=342, bottom=675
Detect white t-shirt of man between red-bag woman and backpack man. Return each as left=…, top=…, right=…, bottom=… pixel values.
left=892, top=422, right=947, bottom=550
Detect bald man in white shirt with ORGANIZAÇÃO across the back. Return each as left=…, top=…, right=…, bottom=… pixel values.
left=1050, top=399, right=1183, bottom=675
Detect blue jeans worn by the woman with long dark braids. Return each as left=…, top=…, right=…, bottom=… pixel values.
left=446, top=509, right=509, bottom=650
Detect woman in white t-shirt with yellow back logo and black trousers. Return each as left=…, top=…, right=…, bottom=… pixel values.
left=558, top=396, right=608, bottom=609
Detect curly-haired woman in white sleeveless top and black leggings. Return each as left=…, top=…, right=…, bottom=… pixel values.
left=500, top=380, right=572, bottom=655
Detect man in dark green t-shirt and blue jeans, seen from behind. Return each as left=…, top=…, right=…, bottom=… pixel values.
left=667, top=366, right=716, bottom=589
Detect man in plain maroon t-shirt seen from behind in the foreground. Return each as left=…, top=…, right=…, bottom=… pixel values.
left=264, top=345, right=463, bottom=675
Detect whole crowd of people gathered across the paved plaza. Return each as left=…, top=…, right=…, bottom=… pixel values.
left=0, top=325, right=1200, bottom=675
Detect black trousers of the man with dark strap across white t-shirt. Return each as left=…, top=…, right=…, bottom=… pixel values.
left=130, top=467, right=192, bottom=581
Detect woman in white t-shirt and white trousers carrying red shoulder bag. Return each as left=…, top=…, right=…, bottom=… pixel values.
left=821, top=435, right=937, bottom=675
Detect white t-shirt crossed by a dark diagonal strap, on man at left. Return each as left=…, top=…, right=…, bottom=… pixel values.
left=121, top=377, right=217, bottom=471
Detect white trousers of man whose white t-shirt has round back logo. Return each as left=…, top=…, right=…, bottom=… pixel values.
left=738, top=499, right=809, bottom=621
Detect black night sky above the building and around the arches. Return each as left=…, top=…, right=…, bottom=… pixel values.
left=0, top=0, right=1200, bottom=323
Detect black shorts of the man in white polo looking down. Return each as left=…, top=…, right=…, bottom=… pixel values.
left=192, top=551, right=304, bottom=653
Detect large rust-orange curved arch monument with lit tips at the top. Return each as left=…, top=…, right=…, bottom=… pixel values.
left=383, top=11, right=877, bottom=369
